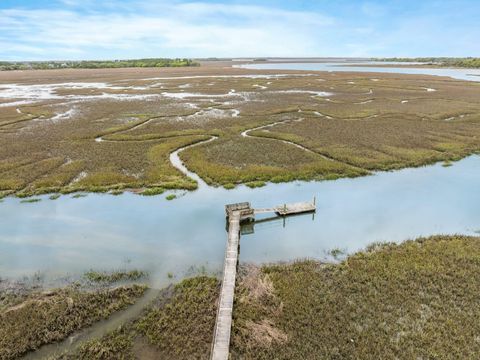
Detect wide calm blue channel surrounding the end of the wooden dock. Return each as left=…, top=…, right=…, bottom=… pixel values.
left=0, top=156, right=480, bottom=286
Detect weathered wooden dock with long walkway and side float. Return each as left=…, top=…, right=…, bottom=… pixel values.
left=210, top=199, right=315, bottom=360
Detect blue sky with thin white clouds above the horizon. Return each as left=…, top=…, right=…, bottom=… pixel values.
left=0, top=0, right=480, bottom=60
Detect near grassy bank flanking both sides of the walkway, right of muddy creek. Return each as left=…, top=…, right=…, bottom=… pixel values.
left=25, top=236, right=480, bottom=359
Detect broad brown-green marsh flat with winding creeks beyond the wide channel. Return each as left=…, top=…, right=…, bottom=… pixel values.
left=0, top=61, right=480, bottom=196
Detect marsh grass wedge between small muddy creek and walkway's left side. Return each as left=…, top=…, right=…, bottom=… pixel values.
left=63, top=276, right=219, bottom=359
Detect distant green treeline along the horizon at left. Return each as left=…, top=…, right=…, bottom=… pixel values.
left=0, top=59, right=200, bottom=71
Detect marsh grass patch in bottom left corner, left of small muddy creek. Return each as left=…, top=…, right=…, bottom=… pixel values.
left=0, top=285, right=146, bottom=359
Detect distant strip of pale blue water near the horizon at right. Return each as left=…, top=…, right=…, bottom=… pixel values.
left=239, top=62, right=480, bottom=81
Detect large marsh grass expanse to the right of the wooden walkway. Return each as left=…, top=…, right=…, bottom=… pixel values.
left=231, top=236, right=480, bottom=359
